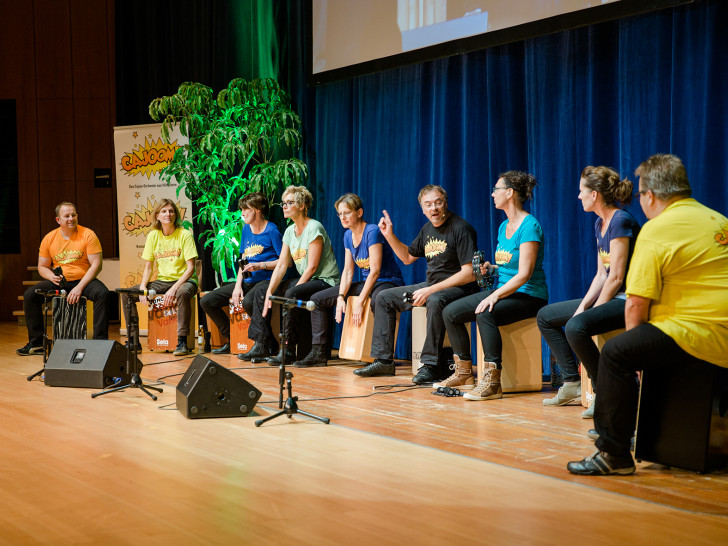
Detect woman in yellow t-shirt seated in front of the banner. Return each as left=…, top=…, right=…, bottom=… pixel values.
left=121, top=199, right=197, bottom=356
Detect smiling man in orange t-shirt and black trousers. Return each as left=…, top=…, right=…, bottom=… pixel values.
left=16, top=201, right=109, bottom=356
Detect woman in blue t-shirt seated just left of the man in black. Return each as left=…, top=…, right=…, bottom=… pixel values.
left=294, top=193, right=404, bottom=367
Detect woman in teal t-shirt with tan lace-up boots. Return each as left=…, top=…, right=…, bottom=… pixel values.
left=436, top=171, right=549, bottom=400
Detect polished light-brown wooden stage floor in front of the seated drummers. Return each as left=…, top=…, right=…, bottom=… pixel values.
left=0, top=322, right=728, bottom=545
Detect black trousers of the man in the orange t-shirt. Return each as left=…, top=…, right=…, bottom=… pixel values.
left=23, top=279, right=109, bottom=347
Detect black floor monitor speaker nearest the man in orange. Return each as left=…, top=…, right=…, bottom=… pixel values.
left=44, top=339, right=142, bottom=389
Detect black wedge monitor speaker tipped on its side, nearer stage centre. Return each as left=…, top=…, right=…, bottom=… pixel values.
left=177, top=355, right=261, bottom=419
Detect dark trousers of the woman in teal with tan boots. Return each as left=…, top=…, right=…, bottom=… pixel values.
left=442, top=290, right=546, bottom=369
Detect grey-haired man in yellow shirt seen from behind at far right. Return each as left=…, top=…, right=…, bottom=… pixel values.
left=567, top=154, right=728, bottom=475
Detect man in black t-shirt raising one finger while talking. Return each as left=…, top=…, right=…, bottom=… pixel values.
left=354, top=185, right=477, bottom=385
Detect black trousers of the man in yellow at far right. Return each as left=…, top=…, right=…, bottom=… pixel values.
left=594, top=324, right=705, bottom=457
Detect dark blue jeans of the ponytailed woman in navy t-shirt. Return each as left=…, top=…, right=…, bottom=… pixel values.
left=537, top=298, right=624, bottom=384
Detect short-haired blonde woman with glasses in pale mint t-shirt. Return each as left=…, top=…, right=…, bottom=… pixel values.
left=263, top=186, right=340, bottom=366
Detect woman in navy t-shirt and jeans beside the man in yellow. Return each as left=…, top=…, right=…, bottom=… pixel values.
left=538, top=167, right=640, bottom=419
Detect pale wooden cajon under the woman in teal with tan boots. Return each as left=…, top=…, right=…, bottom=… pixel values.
left=476, top=317, right=543, bottom=392
